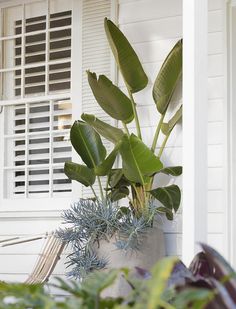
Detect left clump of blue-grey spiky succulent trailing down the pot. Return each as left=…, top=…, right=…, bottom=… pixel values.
left=57, top=199, right=119, bottom=278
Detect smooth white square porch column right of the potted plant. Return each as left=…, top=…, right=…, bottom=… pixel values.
left=182, top=0, right=208, bottom=264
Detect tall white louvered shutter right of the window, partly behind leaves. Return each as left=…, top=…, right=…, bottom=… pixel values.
left=82, top=0, right=111, bottom=197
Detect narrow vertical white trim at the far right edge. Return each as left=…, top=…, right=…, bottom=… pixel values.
left=225, top=0, right=236, bottom=267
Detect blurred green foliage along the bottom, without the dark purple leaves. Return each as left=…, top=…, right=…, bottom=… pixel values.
left=0, top=258, right=212, bottom=309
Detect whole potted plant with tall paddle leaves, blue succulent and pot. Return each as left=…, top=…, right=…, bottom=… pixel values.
left=58, top=19, right=182, bottom=292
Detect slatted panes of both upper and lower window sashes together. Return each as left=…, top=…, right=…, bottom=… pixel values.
left=2, top=0, right=72, bottom=198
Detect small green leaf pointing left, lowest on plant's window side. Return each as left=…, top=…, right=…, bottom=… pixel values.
left=64, top=161, right=96, bottom=187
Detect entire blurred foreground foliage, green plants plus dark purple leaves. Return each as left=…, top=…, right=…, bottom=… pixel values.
left=0, top=244, right=236, bottom=309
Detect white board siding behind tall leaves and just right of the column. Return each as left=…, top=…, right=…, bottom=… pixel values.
left=118, top=0, right=227, bottom=255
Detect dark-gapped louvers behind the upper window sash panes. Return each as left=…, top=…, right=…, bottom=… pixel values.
left=15, top=11, right=71, bottom=97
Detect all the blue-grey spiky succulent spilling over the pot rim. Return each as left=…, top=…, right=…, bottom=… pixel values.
left=57, top=199, right=159, bottom=279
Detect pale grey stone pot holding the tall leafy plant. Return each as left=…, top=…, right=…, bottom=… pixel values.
left=95, top=221, right=165, bottom=297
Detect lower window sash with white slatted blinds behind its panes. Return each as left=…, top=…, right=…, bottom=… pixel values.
left=11, top=98, right=71, bottom=197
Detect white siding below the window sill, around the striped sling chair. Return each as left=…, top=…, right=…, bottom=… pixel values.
left=0, top=212, right=65, bottom=281
